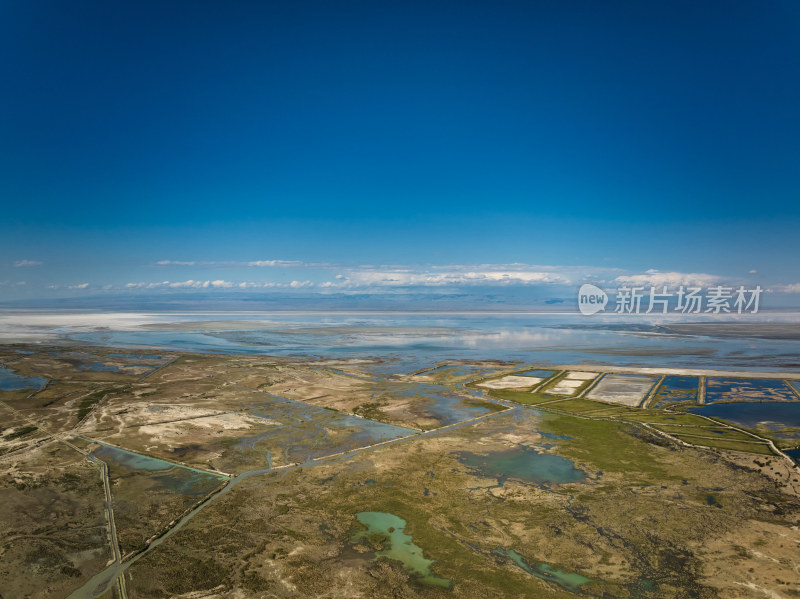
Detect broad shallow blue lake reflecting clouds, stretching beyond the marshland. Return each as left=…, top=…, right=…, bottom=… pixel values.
left=51, top=313, right=800, bottom=370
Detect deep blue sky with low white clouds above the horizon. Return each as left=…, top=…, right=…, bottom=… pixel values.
left=0, top=0, right=800, bottom=300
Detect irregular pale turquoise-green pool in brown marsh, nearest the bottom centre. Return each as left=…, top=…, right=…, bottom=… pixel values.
left=351, top=512, right=453, bottom=589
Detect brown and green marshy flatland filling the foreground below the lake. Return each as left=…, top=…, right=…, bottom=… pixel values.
left=0, top=347, right=800, bottom=599
